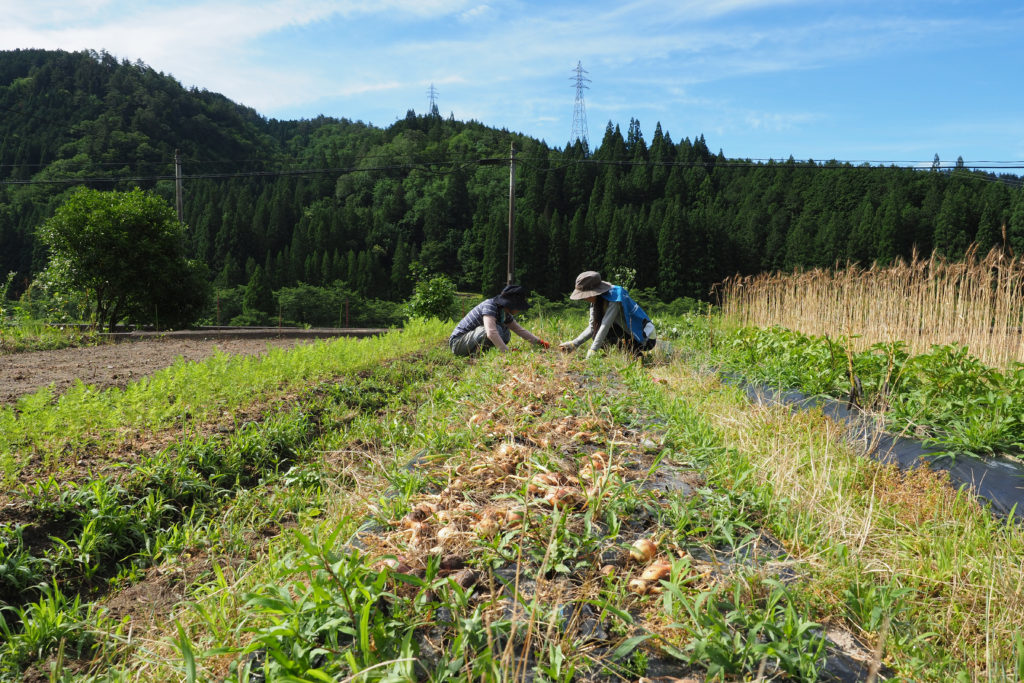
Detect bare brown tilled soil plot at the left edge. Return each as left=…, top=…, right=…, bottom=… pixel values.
left=0, top=336, right=313, bottom=407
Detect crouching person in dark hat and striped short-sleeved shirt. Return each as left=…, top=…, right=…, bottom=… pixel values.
left=449, top=285, right=551, bottom=355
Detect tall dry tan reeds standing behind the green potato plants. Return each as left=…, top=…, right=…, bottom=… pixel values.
left=722, top=249, right=1024, bottom=368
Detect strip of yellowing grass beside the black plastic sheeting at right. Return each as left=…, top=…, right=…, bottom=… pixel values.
left=634, top=364, right=1024, bottom=681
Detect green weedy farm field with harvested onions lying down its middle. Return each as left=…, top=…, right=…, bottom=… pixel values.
left=0, top=318, right=1024, bottom=681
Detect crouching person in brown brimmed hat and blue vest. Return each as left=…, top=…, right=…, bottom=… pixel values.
left=558, top=270, right=655, bottom=358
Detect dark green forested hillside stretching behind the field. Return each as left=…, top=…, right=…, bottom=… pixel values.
left=0, top=50, right=1024, bottom=300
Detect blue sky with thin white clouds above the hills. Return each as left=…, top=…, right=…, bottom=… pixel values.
left=0, top=0, right=1024, bottom=168
